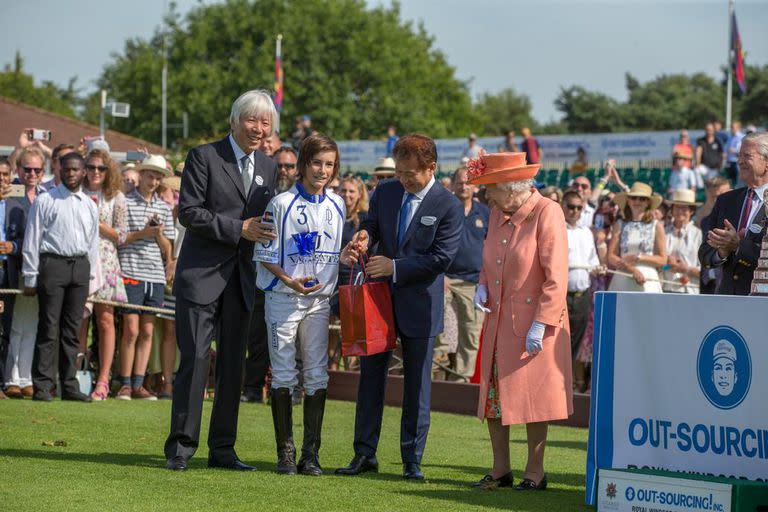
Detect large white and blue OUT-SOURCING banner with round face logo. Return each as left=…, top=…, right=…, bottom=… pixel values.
left=587, top=292, right=768, bottom=504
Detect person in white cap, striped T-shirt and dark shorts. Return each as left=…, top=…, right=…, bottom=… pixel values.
left=115, top=155, right=175, bottom=400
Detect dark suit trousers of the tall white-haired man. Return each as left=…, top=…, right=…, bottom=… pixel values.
left=165, top=270, right=250, bottom=463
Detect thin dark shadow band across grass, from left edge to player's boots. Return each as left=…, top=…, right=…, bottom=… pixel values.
left=0, top=448, right=275, bottom=471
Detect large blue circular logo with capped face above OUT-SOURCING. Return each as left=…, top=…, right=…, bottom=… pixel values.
left=697, top=325, right=752, bottom=410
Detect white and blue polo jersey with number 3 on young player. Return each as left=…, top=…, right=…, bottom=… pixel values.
left=253, top=183, right=346, bottom=295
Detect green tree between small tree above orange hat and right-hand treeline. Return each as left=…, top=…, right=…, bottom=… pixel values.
left=555, top=85, right=625, bottom=133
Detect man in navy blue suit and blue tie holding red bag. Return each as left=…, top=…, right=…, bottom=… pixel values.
left=336, top=135, right=462, bottom=480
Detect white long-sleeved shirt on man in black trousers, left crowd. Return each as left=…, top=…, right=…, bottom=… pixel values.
left=22, top=184, right=99, bottom=288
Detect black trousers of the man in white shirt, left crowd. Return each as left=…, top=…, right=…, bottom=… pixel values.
left=32, top=254, right=91, bottom=396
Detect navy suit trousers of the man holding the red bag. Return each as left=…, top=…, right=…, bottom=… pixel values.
left=354, top=336, right=435, bottom=464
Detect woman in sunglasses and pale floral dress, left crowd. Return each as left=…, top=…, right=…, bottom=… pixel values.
left=81, top=149, right=127, bottom=400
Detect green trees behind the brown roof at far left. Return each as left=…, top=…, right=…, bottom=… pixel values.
left=0, top=52, right=79, bottom=117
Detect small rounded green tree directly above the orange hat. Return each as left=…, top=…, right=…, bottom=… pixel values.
left=475, top=88, right=537, bottom=135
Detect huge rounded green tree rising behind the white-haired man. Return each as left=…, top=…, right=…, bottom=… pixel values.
left=90, top=0, right=479, bottom=146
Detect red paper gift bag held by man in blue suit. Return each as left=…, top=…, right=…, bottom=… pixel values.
left=339, top=260, right=397, bottom=357
